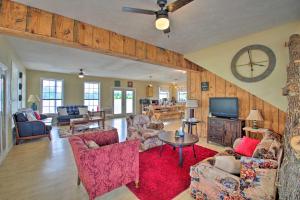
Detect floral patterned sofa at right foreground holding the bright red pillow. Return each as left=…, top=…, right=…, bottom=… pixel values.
left=190, top=132, right=283, bottom=200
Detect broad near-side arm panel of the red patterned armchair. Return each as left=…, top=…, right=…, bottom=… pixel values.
left=79, top=140, right=140, bottom=194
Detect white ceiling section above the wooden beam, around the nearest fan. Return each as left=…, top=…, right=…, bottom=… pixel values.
left=16, top=0, right=300, bottom=53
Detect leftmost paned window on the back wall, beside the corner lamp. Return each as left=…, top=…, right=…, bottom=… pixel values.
left=42, top=79, right=63, bottom=113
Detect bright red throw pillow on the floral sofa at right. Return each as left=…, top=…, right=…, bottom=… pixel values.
left=234, top=137, right=260, bottom=157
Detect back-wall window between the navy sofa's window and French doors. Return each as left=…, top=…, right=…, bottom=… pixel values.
left=84, top=82, right=100, bottom=111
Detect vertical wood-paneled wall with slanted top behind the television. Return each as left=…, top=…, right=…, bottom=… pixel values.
left=187, top=71, right=286, bottom=137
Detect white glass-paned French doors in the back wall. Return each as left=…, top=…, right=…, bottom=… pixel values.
left=112, top=88, right=135, bottom=117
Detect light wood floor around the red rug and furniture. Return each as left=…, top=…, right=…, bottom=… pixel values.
left=0, top=119, right=223, bottom=200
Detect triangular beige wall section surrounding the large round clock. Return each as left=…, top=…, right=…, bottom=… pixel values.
left=185, top=21, right=300, bottom=111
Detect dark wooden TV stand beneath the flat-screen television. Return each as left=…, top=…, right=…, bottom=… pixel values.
left=207, top=117, right=245, bottom=147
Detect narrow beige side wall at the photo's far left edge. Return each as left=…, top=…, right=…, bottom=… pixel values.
left=0, top=35, right=26, bottom=156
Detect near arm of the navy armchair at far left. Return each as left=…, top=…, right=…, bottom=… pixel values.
left=17, top=121, right=47, bottom=137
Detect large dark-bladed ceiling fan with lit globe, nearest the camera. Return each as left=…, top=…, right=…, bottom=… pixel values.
left=122, top=0, right=193, bottom=33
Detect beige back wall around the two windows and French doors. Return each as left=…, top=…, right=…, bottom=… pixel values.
left=26, top=70, right=164, bottom=113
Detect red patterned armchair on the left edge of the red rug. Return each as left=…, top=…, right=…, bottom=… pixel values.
left=69, top=130, right=140, bottom=200
